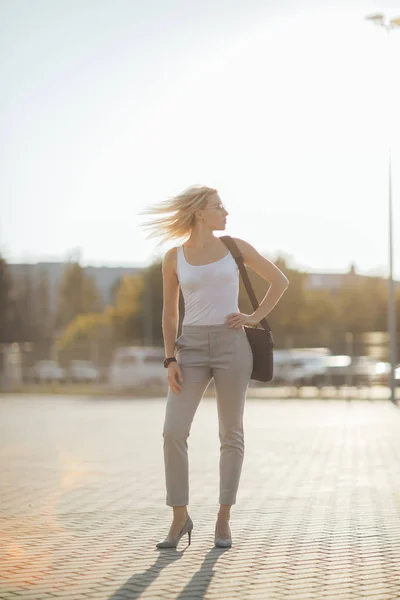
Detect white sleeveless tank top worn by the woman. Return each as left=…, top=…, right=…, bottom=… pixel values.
left=177, top=246, right=239, bottom=325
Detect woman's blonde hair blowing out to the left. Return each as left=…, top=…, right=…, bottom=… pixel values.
left=139, top=185, right=217, bottom=247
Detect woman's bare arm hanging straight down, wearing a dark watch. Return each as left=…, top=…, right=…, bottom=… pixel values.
left=162, top=248, right=179, bottom=357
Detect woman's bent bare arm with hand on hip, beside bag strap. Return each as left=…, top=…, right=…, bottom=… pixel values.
left=234, top=238, right=289, bottom=323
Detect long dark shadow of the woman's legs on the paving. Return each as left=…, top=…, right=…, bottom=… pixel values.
left=109, top=548, right=227, bottom=600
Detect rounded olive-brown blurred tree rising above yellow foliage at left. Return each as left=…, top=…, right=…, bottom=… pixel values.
left=55, top=262, right=103, bottom=330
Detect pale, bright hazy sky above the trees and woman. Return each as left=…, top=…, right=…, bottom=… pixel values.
left=0, top=0, right=400, bottom=280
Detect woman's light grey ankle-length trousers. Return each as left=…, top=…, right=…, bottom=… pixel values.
left=163, top=324, right=253, bottom=506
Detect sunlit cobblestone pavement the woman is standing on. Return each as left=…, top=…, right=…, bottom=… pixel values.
left=0, top=396, right=400, bottom=600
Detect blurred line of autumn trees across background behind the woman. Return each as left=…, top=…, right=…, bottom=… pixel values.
left=0, top=251, right=400, bottom=357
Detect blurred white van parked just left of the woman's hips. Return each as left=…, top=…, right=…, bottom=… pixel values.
left=109, top=346, right=168, bottom=389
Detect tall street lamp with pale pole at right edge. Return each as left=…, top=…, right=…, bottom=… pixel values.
left=365, top=14, right=400, bottom=404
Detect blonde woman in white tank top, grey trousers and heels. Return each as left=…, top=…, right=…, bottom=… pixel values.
left=144, top=186, right=289, bottom=548
